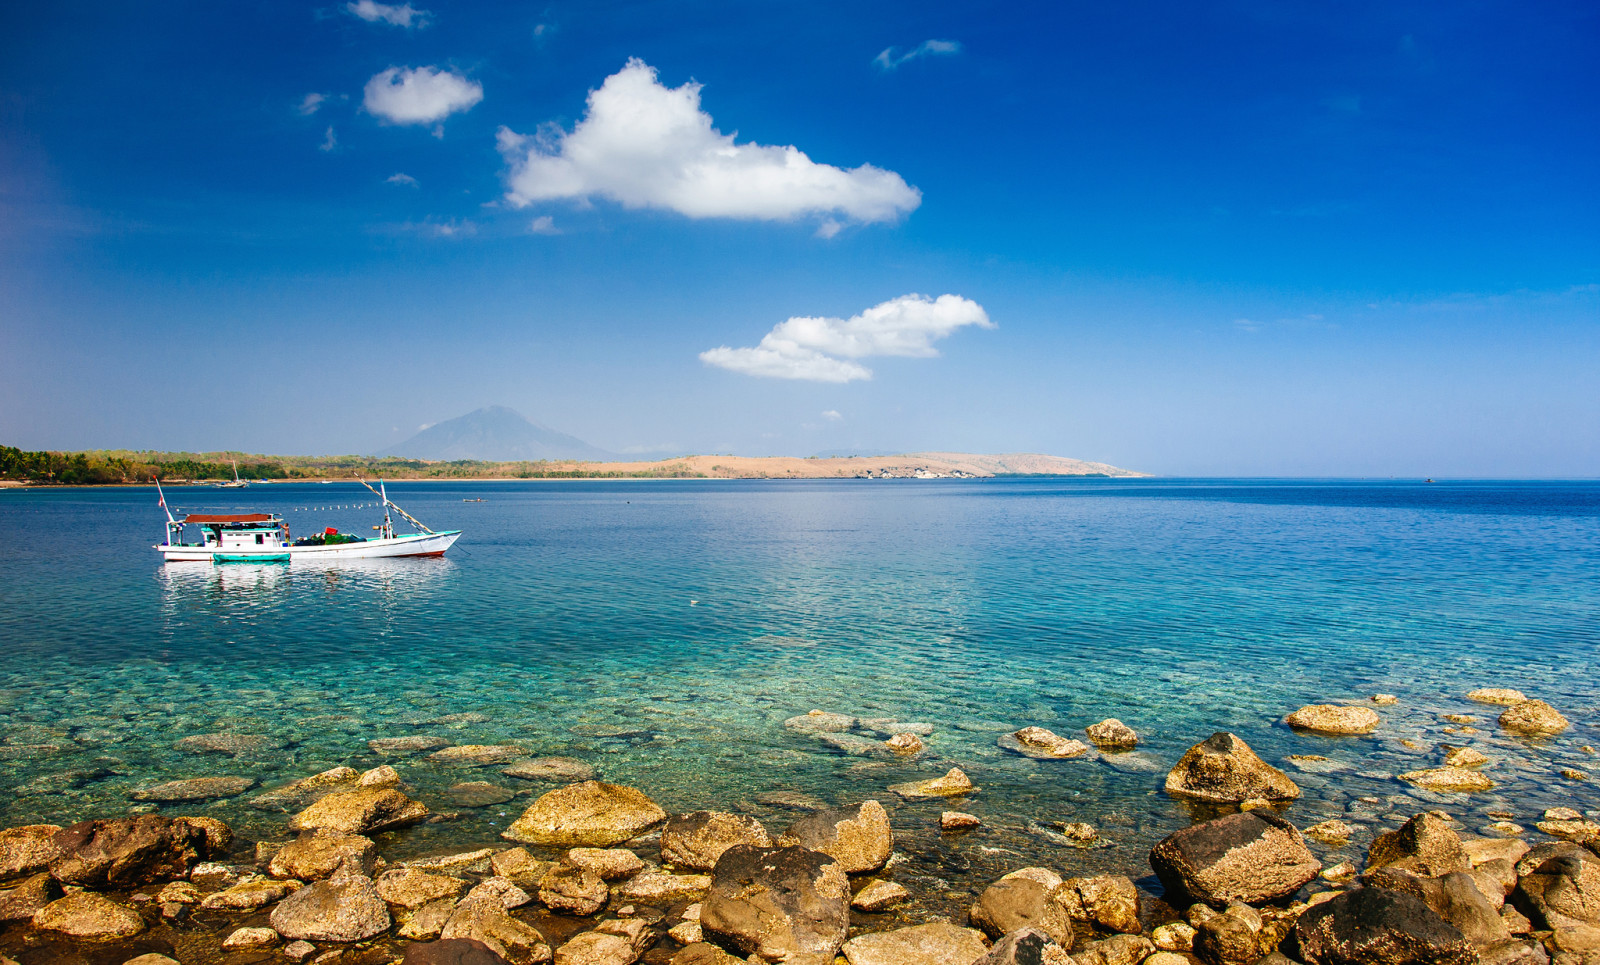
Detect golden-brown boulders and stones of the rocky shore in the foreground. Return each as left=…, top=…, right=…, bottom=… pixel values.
left=0, top=691, right=1600, bottom=965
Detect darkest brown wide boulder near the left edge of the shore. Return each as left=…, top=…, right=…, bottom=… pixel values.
left=50, top=815, right=213, bottom=888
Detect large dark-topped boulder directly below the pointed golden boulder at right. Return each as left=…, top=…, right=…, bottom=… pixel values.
left=1150, top=810, right=1322, bottom=907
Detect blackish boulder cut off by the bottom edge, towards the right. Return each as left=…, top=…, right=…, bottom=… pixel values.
left=1294, top=888, right=1478, bottom=965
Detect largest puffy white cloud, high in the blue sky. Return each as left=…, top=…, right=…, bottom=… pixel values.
left=499, top=58, right=922, bottom=221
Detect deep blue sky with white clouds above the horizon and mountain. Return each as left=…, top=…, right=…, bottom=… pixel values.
left=0, top=0, right=1600, bottom=475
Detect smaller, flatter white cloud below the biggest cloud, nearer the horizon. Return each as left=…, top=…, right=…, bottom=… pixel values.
left=699, top=294, right=995, bottom=382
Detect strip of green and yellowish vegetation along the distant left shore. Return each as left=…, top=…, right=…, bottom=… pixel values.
left=0, top=446, right=704, bottom=487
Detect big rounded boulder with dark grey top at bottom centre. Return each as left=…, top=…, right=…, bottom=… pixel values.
left=701, top=845, right=850, bottom=965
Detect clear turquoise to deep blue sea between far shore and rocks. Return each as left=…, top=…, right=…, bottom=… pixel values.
left=0, top=478, right=1600, bottom=901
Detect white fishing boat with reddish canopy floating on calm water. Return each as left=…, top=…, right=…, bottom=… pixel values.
left=154, top=480, right=461, bottom=563
